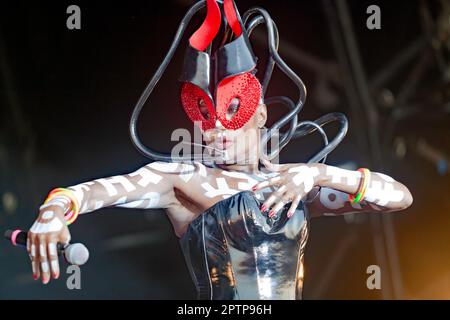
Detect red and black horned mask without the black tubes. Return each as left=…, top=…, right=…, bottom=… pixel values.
left=180, top=0, right=262, bottom=130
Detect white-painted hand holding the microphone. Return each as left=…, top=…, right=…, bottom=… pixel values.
left=27, top=203, right=70, bottom=284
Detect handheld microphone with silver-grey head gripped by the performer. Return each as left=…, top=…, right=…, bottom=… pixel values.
left=5, top=230, right=89, bottom=266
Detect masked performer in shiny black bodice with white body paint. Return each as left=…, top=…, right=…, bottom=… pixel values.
left=27, top=0, right=412, bottom=299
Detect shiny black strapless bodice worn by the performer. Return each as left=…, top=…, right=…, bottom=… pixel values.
left=180, top=191, right=308, bottom=300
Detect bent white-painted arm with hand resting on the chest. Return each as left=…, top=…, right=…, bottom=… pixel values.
left=254, top=162, right=412, bottom=217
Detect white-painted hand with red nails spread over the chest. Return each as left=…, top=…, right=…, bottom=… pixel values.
left=252, top=160, right=320, bottom=218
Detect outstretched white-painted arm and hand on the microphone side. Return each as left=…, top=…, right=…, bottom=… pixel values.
left=27, top=162, right=195, bottom=284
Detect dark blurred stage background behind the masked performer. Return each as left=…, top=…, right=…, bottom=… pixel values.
left=0, top=0, right=450, bottom=299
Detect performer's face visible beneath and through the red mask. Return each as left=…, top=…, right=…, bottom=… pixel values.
left=200, top=102, right=267, bottom=164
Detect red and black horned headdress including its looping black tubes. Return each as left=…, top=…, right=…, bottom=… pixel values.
left=130, top=0, right=347, bottom=162
